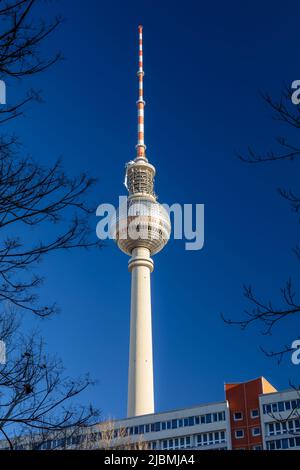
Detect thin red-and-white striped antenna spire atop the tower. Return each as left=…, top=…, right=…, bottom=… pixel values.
left=136, top=25, right=147, bottom=161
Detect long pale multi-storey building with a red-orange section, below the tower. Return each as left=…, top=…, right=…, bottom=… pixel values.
left=0, top=377, right=300, bottom=451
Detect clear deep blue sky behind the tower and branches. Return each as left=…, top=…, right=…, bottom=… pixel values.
left=8, top=0, right=300, bottom=417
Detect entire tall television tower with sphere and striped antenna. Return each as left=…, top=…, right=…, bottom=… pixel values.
left=113, top=26, right=171, bottom=417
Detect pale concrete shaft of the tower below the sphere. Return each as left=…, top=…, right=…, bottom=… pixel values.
left=127, top=247, right=154, bottom=417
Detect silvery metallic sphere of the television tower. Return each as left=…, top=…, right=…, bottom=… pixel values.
left=112, top=197, right=171, bottom=255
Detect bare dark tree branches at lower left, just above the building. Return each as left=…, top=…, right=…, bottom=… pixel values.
left=0, top=313, right=98, bottom=449
